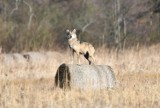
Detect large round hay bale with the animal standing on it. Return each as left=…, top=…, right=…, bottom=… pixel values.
left=55, top=64, right=116, bottom=89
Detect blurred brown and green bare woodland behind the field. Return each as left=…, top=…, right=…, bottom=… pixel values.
left=0, top=0, right=160, bottom=52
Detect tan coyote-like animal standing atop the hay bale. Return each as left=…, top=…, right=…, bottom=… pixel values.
left=66, top=29, right=95, bottom=65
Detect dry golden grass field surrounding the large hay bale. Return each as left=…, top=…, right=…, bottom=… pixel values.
left=0, top=45, right=160, bottom=108
